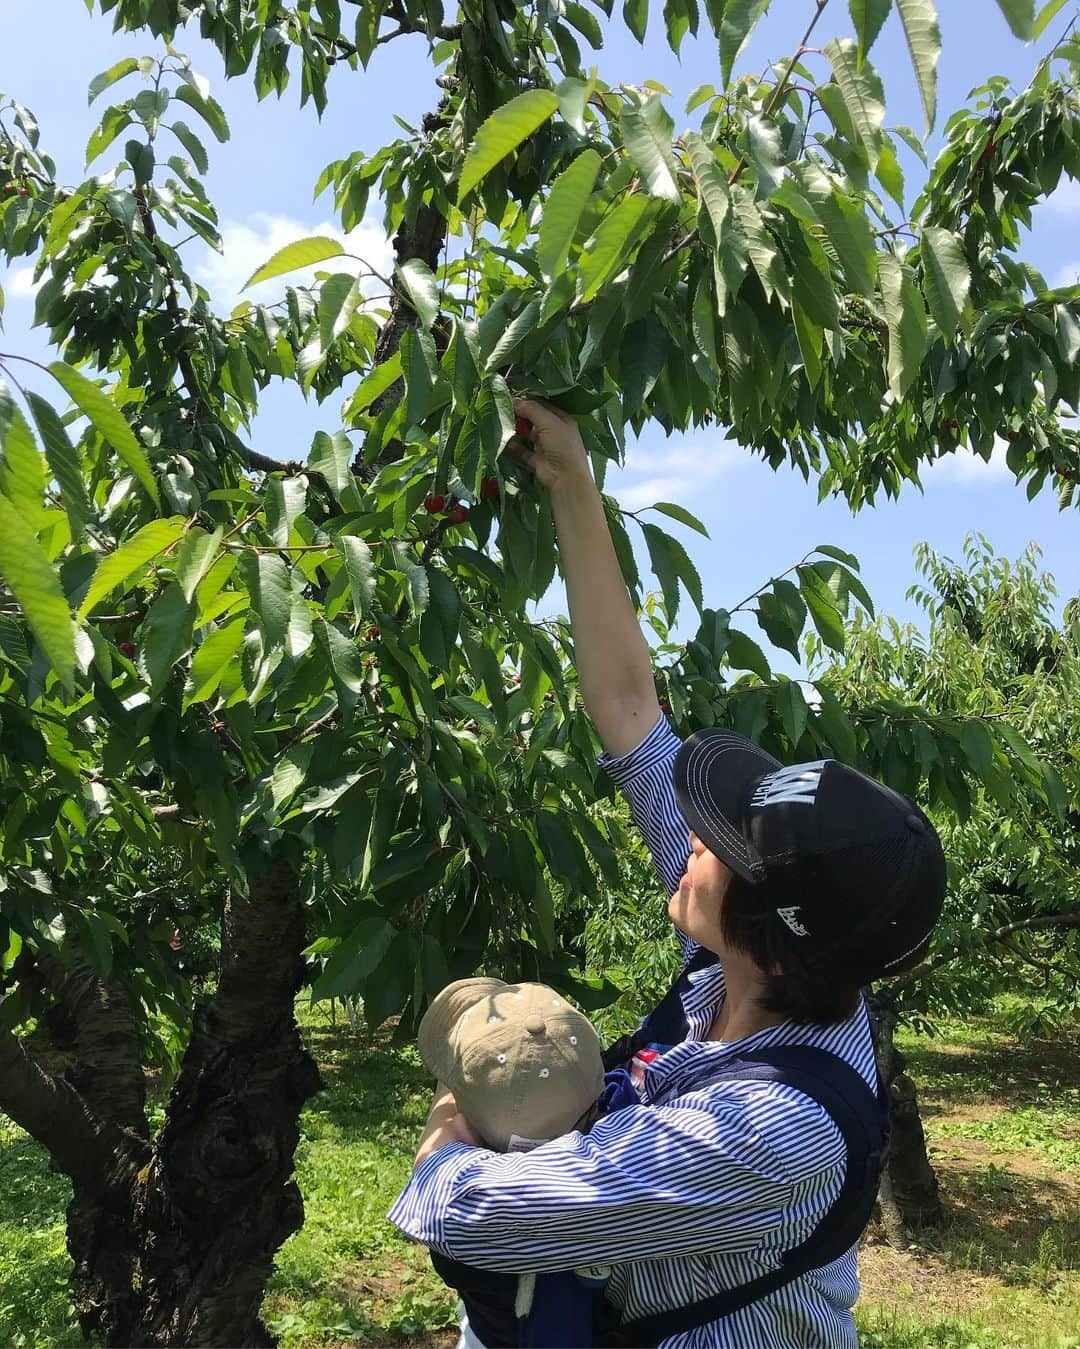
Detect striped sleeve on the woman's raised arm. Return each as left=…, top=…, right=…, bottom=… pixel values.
left=600, top=716, right=693, bottom=952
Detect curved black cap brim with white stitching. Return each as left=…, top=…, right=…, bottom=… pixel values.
left=674, top=728, right=782, bottom=881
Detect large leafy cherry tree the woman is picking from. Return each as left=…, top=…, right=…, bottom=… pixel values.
left=0, top=0, right=1080, bottom=1345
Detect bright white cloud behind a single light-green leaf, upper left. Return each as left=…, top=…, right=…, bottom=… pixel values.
left=191, top=210, right=394, bottom=310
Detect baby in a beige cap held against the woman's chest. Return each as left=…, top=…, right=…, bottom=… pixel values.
left=418, top=978, right=638, bottom=1349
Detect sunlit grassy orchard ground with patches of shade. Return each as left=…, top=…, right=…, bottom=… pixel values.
left=0, top=998, right=1080, bottom=1349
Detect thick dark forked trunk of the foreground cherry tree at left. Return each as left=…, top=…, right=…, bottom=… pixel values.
left=0, top=862, right=322, bottom=1346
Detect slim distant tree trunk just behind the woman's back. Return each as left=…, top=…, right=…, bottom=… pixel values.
left=867, top=989, right=944, bottom=1245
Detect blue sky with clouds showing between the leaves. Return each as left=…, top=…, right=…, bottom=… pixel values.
left=0, top=0, right=1080, bottom=668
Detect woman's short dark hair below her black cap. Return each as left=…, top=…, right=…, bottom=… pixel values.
left=720, top=873, right=859, bottom=1025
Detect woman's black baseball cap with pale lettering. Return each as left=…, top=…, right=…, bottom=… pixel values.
left=674, top=730, right=945, bottom=983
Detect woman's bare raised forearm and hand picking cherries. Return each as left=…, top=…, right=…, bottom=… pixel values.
left=514, top=398, right=659, bottom=755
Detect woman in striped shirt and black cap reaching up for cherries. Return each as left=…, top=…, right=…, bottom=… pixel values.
left=391, top=399, right=945, bottom=1349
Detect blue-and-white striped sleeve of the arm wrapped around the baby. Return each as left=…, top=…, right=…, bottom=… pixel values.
left=390, top=1097, right=844, bottom=1273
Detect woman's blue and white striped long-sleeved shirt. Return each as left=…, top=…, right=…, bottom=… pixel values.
left=390, top=718, right=876, bottom=1349
